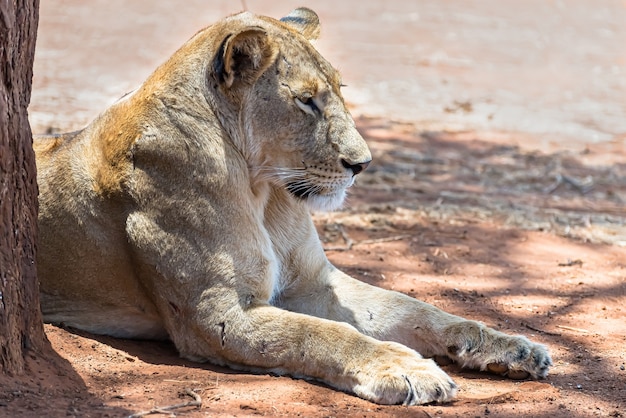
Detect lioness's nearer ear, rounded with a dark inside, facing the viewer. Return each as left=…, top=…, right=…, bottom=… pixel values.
left=213, top=27, right=278, bottom=88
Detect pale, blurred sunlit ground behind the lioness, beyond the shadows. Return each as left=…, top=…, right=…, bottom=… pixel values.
left=30, top=0, right=626, bottom=154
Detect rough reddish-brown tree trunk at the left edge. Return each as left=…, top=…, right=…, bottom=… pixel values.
left=0, top=0, right=48, bottom=375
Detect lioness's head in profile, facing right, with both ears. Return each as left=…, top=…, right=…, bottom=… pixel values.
left=210, top=8, right=371, bottom=209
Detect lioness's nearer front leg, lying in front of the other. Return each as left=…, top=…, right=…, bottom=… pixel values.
left=171, top=295, right=456, bottom=405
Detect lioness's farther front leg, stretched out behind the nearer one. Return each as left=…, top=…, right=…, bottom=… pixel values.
left=276, top=267, right=552, bottom=379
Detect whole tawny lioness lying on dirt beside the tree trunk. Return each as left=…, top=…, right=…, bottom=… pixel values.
left=36, top=8, right=551, bottom=405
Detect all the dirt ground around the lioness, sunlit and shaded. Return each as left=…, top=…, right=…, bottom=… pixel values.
left=0, top=0, right=626, bottom=417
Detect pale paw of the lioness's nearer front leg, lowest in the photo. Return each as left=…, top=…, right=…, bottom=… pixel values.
left=353, top=342, right=457, bottom=405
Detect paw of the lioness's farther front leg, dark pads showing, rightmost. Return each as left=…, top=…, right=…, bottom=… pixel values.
left=445, top=321, right=552, bottom=379
